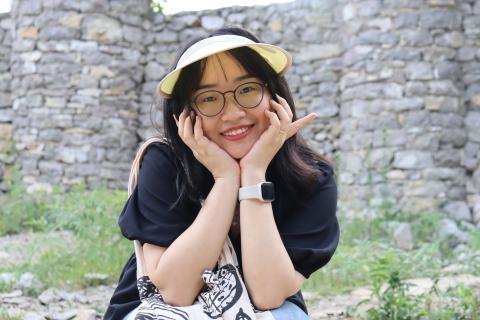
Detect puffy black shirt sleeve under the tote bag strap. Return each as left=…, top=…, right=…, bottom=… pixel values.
left=119, top=143, right=200, bottom=247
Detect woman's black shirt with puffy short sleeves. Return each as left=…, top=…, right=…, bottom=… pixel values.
left=104, top=143, right=340, bottom=320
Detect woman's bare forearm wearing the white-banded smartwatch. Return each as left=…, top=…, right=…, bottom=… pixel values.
left=240, top=175, right=304, bottom=309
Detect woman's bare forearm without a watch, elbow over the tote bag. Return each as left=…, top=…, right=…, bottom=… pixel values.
left=152, top=178, right=239, bottom=305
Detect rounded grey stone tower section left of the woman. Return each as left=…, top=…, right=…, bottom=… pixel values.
left=11, top=0, right=149, bottom=189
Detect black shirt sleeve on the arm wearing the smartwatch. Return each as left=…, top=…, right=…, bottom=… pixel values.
left=279, top=165, right=340, bottom=278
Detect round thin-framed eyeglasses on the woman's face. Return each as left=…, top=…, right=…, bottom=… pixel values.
left=192, top=82, right=267, bottom=117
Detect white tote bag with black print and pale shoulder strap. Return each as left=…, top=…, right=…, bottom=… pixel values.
left=128, top=138, right=274, bottom=320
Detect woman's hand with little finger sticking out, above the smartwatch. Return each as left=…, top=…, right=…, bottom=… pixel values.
left=240, top=95, right=317, bottom=181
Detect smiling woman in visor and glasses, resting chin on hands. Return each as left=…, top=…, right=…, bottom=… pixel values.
left=105, top=28, right=339, bottom=319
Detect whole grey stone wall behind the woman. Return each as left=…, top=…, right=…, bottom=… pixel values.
left=0, top=0, right=480, bottom=226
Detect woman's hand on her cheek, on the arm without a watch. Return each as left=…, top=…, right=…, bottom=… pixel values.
left=173, top=109, right=240, bottom=181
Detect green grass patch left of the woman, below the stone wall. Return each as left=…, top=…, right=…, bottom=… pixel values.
left=0, top=175, right=133, bottom=289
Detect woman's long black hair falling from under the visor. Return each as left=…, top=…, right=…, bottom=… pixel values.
left=157, top=28, right=333, bottom=211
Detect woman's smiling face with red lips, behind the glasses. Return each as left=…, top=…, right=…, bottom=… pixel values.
left=192, top=53, right=271, bottom=160
